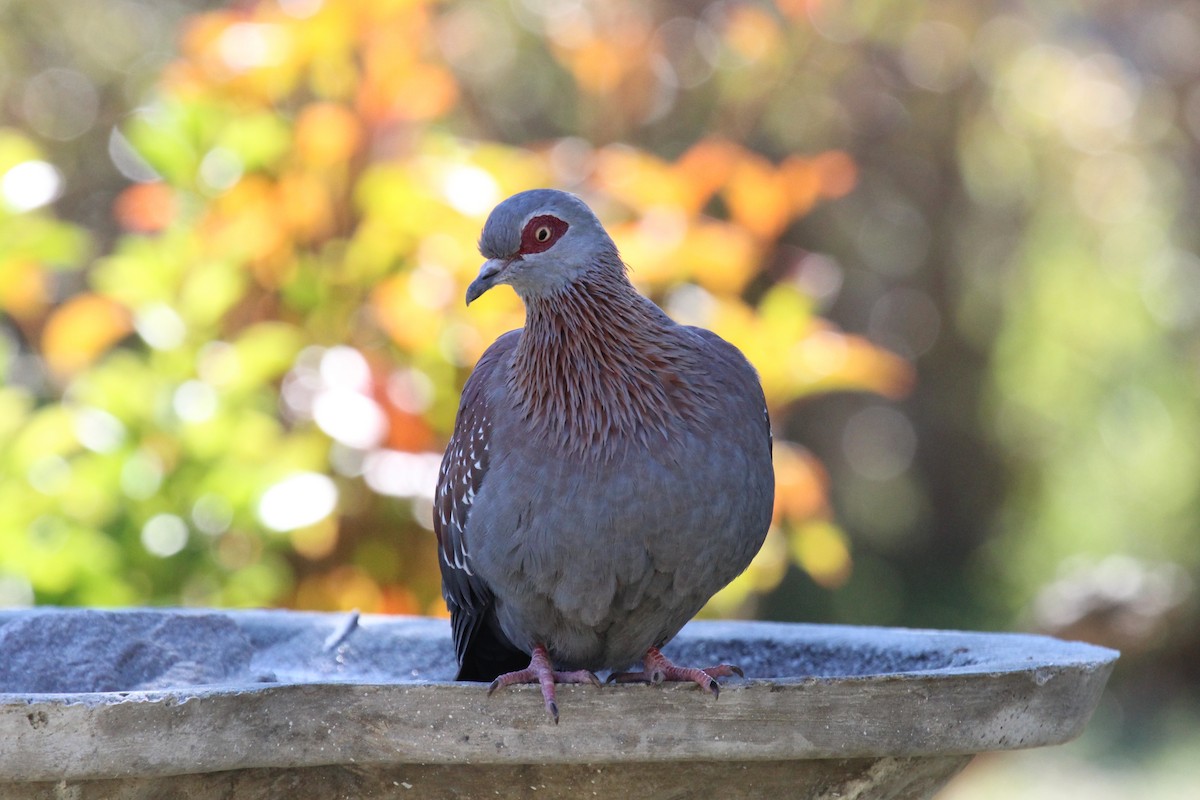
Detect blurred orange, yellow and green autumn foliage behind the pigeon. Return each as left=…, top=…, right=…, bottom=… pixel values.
left=0, top=0, right=912, bottom=613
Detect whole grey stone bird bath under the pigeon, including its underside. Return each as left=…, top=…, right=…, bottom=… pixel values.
left=0, top=609, right=1117, bottom=800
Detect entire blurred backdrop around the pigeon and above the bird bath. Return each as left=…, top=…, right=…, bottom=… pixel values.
left=0, top=0, right=1200, bottom=800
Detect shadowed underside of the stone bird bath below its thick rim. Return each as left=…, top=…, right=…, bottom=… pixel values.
left=0, top=756, right=971, bottom=800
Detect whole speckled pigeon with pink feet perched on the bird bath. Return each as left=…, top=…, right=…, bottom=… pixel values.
left=434, top=190, right=775, bottom=722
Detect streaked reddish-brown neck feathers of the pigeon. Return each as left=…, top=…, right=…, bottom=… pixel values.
left=509, top=268, right=709, bottom=453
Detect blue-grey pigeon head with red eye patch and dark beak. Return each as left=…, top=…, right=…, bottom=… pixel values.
left=467, top=190, right=624, bottom=305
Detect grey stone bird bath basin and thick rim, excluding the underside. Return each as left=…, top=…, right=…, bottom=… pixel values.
left=0, top=609, right=1117, bottom=781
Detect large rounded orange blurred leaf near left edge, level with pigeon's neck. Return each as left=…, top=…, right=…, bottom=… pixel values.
left=42, top=294, right=133, bottom=378
